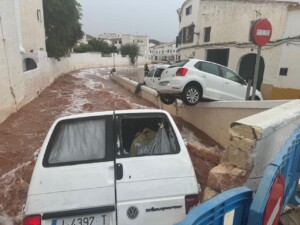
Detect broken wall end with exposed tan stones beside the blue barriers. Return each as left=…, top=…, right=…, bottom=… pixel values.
left=204, top=100, right=300, bottom=200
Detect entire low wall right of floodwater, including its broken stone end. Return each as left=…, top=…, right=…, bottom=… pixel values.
left=113, top=74, right=300, bottom=195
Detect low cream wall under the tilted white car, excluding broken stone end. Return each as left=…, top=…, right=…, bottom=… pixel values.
left=113, top=75, right=288, bottom=146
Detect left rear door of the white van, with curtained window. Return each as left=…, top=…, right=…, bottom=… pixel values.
left=25, top=112, right=116, bottom=225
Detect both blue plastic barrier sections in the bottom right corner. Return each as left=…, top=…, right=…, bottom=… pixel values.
left=176, top=127, right=300, bottom=225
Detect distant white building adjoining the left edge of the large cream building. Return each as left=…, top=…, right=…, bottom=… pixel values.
left=149, top=42, right=177, bottom=62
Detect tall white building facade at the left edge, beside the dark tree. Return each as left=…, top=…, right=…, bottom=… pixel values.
left=0, top=0, right=47, bottom=121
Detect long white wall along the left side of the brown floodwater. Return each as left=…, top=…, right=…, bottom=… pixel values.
left=0, top=52, right=147, bottom=123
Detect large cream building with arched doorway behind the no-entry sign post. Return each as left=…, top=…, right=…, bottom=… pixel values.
left=177, top=0, right=300, bottom=99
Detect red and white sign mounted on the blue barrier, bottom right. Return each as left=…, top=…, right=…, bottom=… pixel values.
left=263, top=174, right=284, bottom=225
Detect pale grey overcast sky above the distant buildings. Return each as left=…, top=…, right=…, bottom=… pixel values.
left=77, top=0, right=184, bottom=42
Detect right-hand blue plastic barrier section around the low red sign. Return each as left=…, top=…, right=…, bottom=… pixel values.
left=248, top=128, right=300, bottom=225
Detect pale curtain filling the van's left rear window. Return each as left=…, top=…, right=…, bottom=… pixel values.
left=48, top=119, right=105, bottom=164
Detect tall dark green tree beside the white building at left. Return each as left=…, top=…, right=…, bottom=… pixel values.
left=43, top=0, right=83, bottom=59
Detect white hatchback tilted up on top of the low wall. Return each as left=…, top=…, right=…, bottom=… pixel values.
left=156, top=59, right=263, bottom=105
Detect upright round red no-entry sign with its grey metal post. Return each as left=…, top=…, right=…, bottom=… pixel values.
left=251, top=19, right=272, bottom=100
